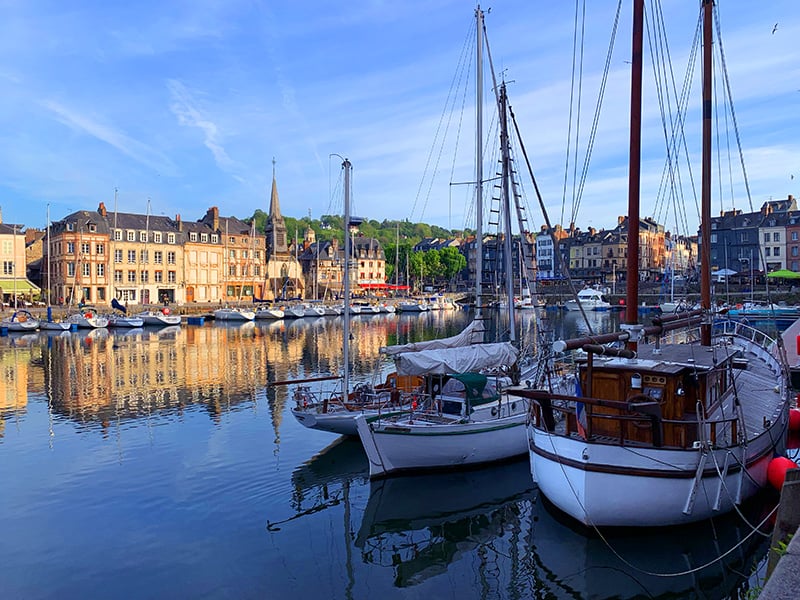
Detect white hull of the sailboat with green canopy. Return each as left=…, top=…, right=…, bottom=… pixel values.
left=356, top=403, right=528, bottom=477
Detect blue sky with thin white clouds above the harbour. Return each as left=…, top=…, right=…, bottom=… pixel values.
left=0, top=0, right=800, bottom=237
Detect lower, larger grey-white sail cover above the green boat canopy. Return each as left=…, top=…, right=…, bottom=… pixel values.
left=394, top=342, right=517, bottom=375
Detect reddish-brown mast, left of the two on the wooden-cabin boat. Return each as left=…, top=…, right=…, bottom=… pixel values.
left=625, top=0, right=644, bottom=352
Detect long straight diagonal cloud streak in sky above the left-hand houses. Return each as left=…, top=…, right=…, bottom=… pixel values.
left=40, top=100, right=178, bottom=175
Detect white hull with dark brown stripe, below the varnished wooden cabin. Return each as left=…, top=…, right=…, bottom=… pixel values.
left=529, top=426, right=780, bottom=527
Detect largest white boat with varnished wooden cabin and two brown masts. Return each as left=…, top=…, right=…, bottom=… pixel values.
left=509, top=0, right=790, bottom=527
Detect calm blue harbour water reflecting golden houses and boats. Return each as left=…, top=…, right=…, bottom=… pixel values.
left=0, top=312, right=774, bottom=600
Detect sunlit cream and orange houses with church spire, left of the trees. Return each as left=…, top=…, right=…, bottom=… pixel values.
left=0, top=176, right=385, bottom=304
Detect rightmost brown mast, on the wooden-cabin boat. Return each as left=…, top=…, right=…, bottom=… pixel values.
left=700, top=0, right=712, bottom=346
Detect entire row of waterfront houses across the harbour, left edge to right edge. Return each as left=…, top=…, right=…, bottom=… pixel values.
left=0, top=188, right=800, bottom=304
